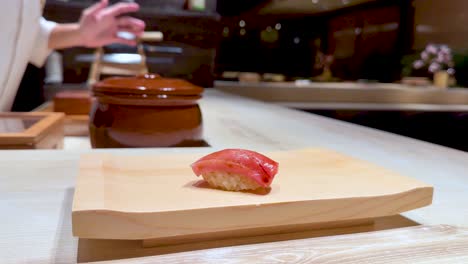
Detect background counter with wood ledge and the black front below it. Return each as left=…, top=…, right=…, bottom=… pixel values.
left=215, top=81, right=468, bottom=151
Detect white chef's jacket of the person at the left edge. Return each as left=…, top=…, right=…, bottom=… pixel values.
left=0, top=0, right=56, bottom=112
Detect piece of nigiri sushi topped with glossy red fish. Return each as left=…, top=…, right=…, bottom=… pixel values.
left=191, top=149, right=279, bottom=191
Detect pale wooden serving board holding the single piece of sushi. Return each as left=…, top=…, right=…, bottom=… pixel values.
left=72, top=149, right=433, bottom=245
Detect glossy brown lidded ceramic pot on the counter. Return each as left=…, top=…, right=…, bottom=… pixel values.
left=89, top=74, right=203, bottom=148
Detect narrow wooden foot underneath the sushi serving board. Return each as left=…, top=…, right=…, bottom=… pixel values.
left=142, top=218, right=374, bottom=248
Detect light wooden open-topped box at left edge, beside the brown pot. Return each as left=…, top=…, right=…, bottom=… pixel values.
left=0, top=112, right=65, bottom=149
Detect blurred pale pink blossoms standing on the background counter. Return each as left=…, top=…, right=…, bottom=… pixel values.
left=413, top=44, right=455, bottom=74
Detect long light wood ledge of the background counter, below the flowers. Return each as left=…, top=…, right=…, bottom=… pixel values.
left=215, top=81, right=468, bottom=112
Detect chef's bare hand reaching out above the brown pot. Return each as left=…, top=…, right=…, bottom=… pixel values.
left=79, top=0, right=145, bottom=48
